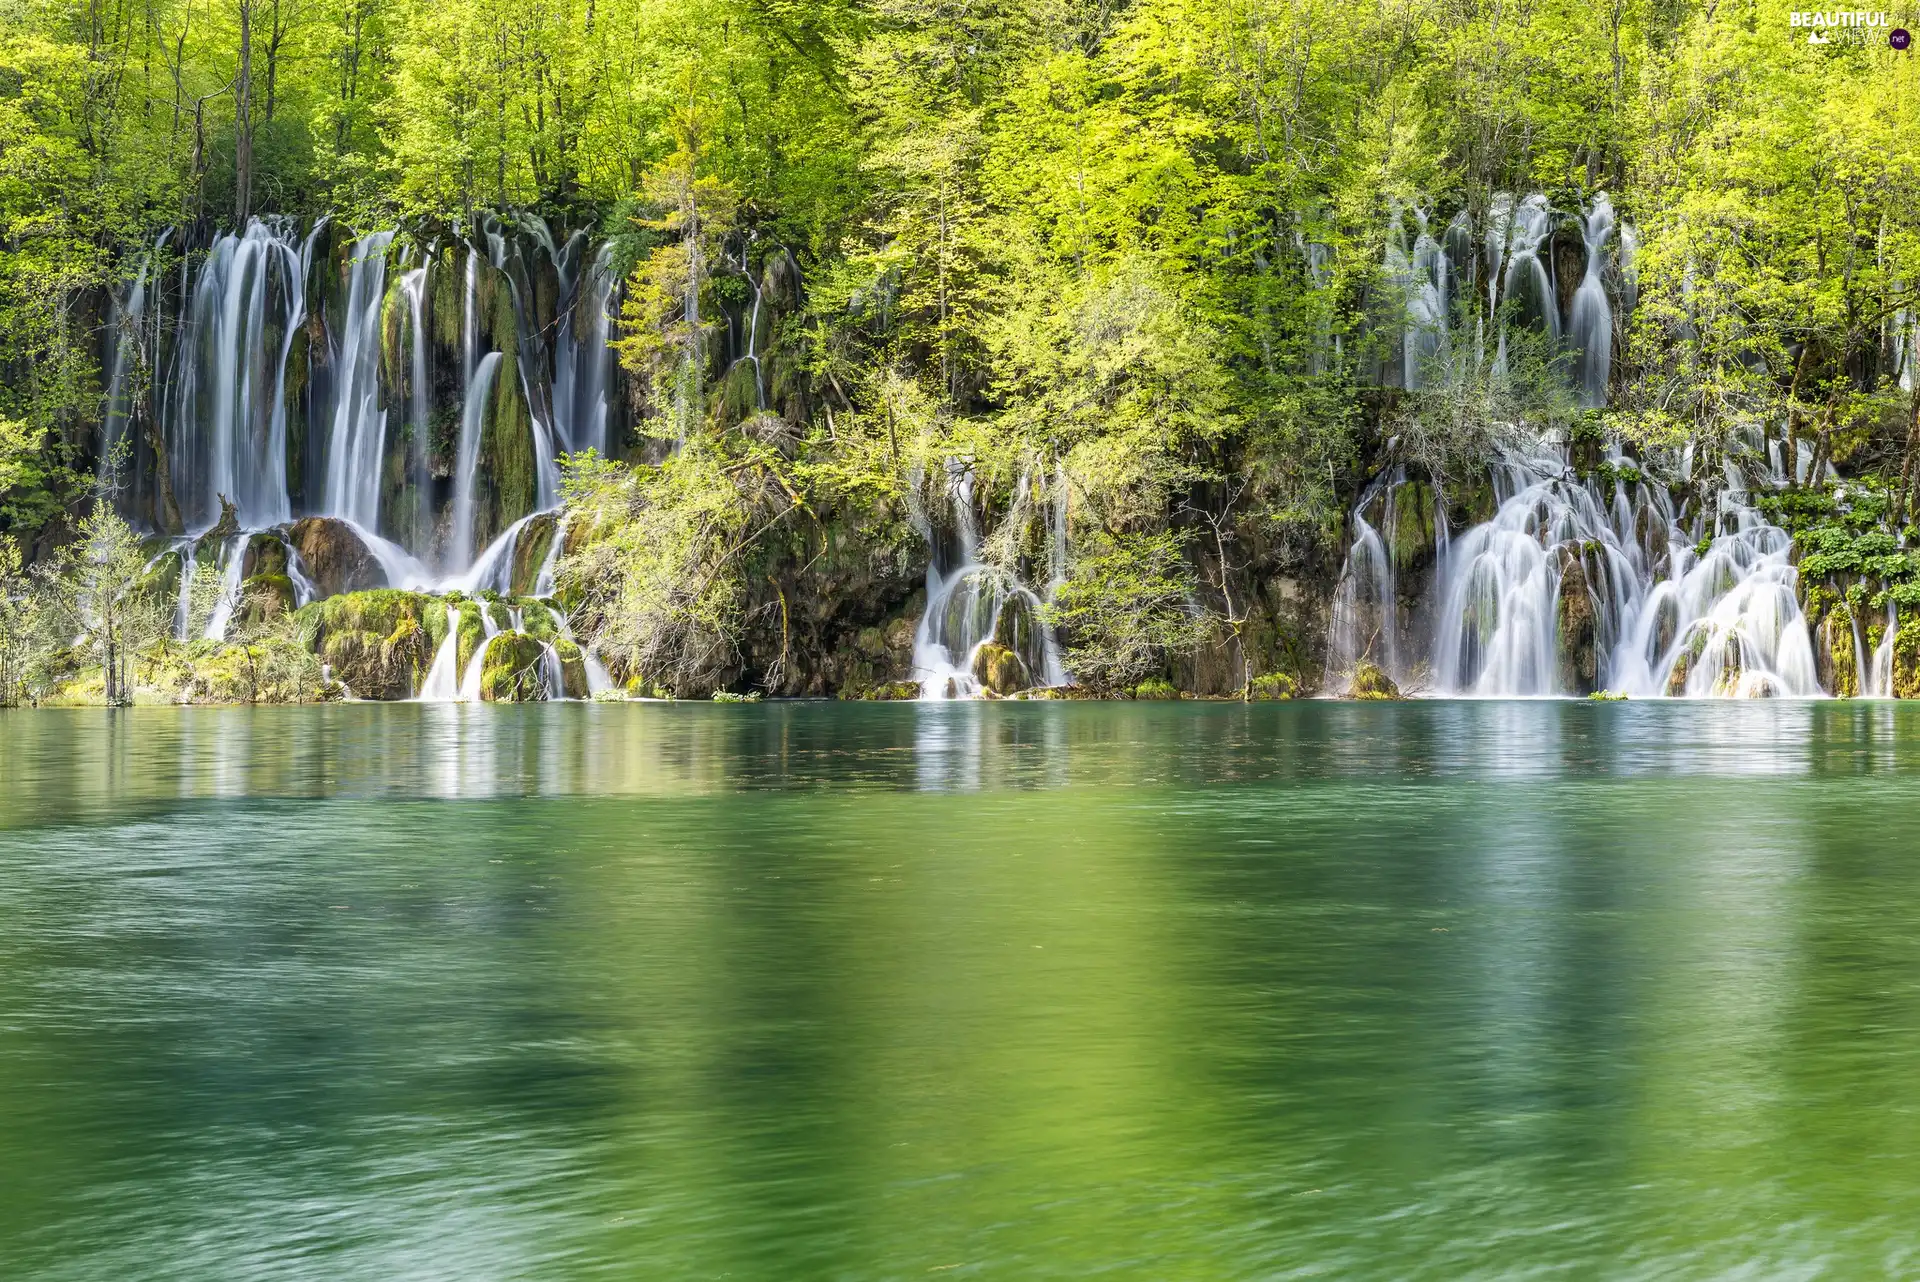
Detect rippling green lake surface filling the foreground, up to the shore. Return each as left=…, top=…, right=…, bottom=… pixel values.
left=0, top=702, right=1920, bottom=1282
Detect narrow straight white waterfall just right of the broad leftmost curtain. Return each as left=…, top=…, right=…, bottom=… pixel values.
left=321, top=232, right=394, bottom=530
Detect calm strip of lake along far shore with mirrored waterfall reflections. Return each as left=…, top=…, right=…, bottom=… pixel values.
left=11, top=700, right=1920, bottom=823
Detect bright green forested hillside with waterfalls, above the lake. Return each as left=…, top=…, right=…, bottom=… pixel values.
left=0, top=0, right=1920, bottom=702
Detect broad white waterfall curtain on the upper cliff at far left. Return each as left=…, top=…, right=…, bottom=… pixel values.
left=156, top=219, right=305, bottom=530
